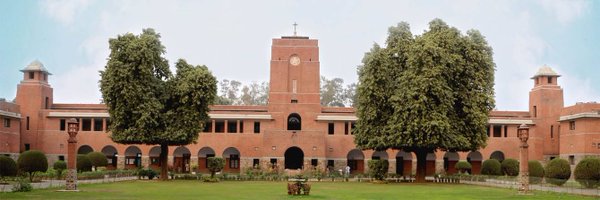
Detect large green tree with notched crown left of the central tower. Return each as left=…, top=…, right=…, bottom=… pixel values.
left=100, top=29, right=217, bottom=180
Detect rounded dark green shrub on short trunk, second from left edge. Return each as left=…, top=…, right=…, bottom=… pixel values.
left=17, top=150, right=48, bottom=182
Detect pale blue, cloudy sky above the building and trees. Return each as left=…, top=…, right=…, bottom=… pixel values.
left=0, top=0, right=600, bottom=110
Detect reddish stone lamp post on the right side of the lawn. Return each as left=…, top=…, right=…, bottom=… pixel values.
left=517, top=124, right=529, bottom=194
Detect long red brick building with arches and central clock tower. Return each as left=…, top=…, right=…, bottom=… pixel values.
left=0, top=36, right=600, bottom=174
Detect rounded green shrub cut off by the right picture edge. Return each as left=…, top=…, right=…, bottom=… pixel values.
left=573, top=158, right=600, bottom=188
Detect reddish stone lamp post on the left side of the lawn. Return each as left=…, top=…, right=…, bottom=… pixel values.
left=65, top=118, right=79, bottom=191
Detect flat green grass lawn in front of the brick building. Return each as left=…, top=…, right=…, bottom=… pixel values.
left=0, top=181, right=593, bottom=200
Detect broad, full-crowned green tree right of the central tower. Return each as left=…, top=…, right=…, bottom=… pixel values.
left=355, top=19, right=495, bottom=181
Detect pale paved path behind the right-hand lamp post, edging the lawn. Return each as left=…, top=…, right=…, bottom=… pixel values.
left=460, top=179, right=600, bottom=196
